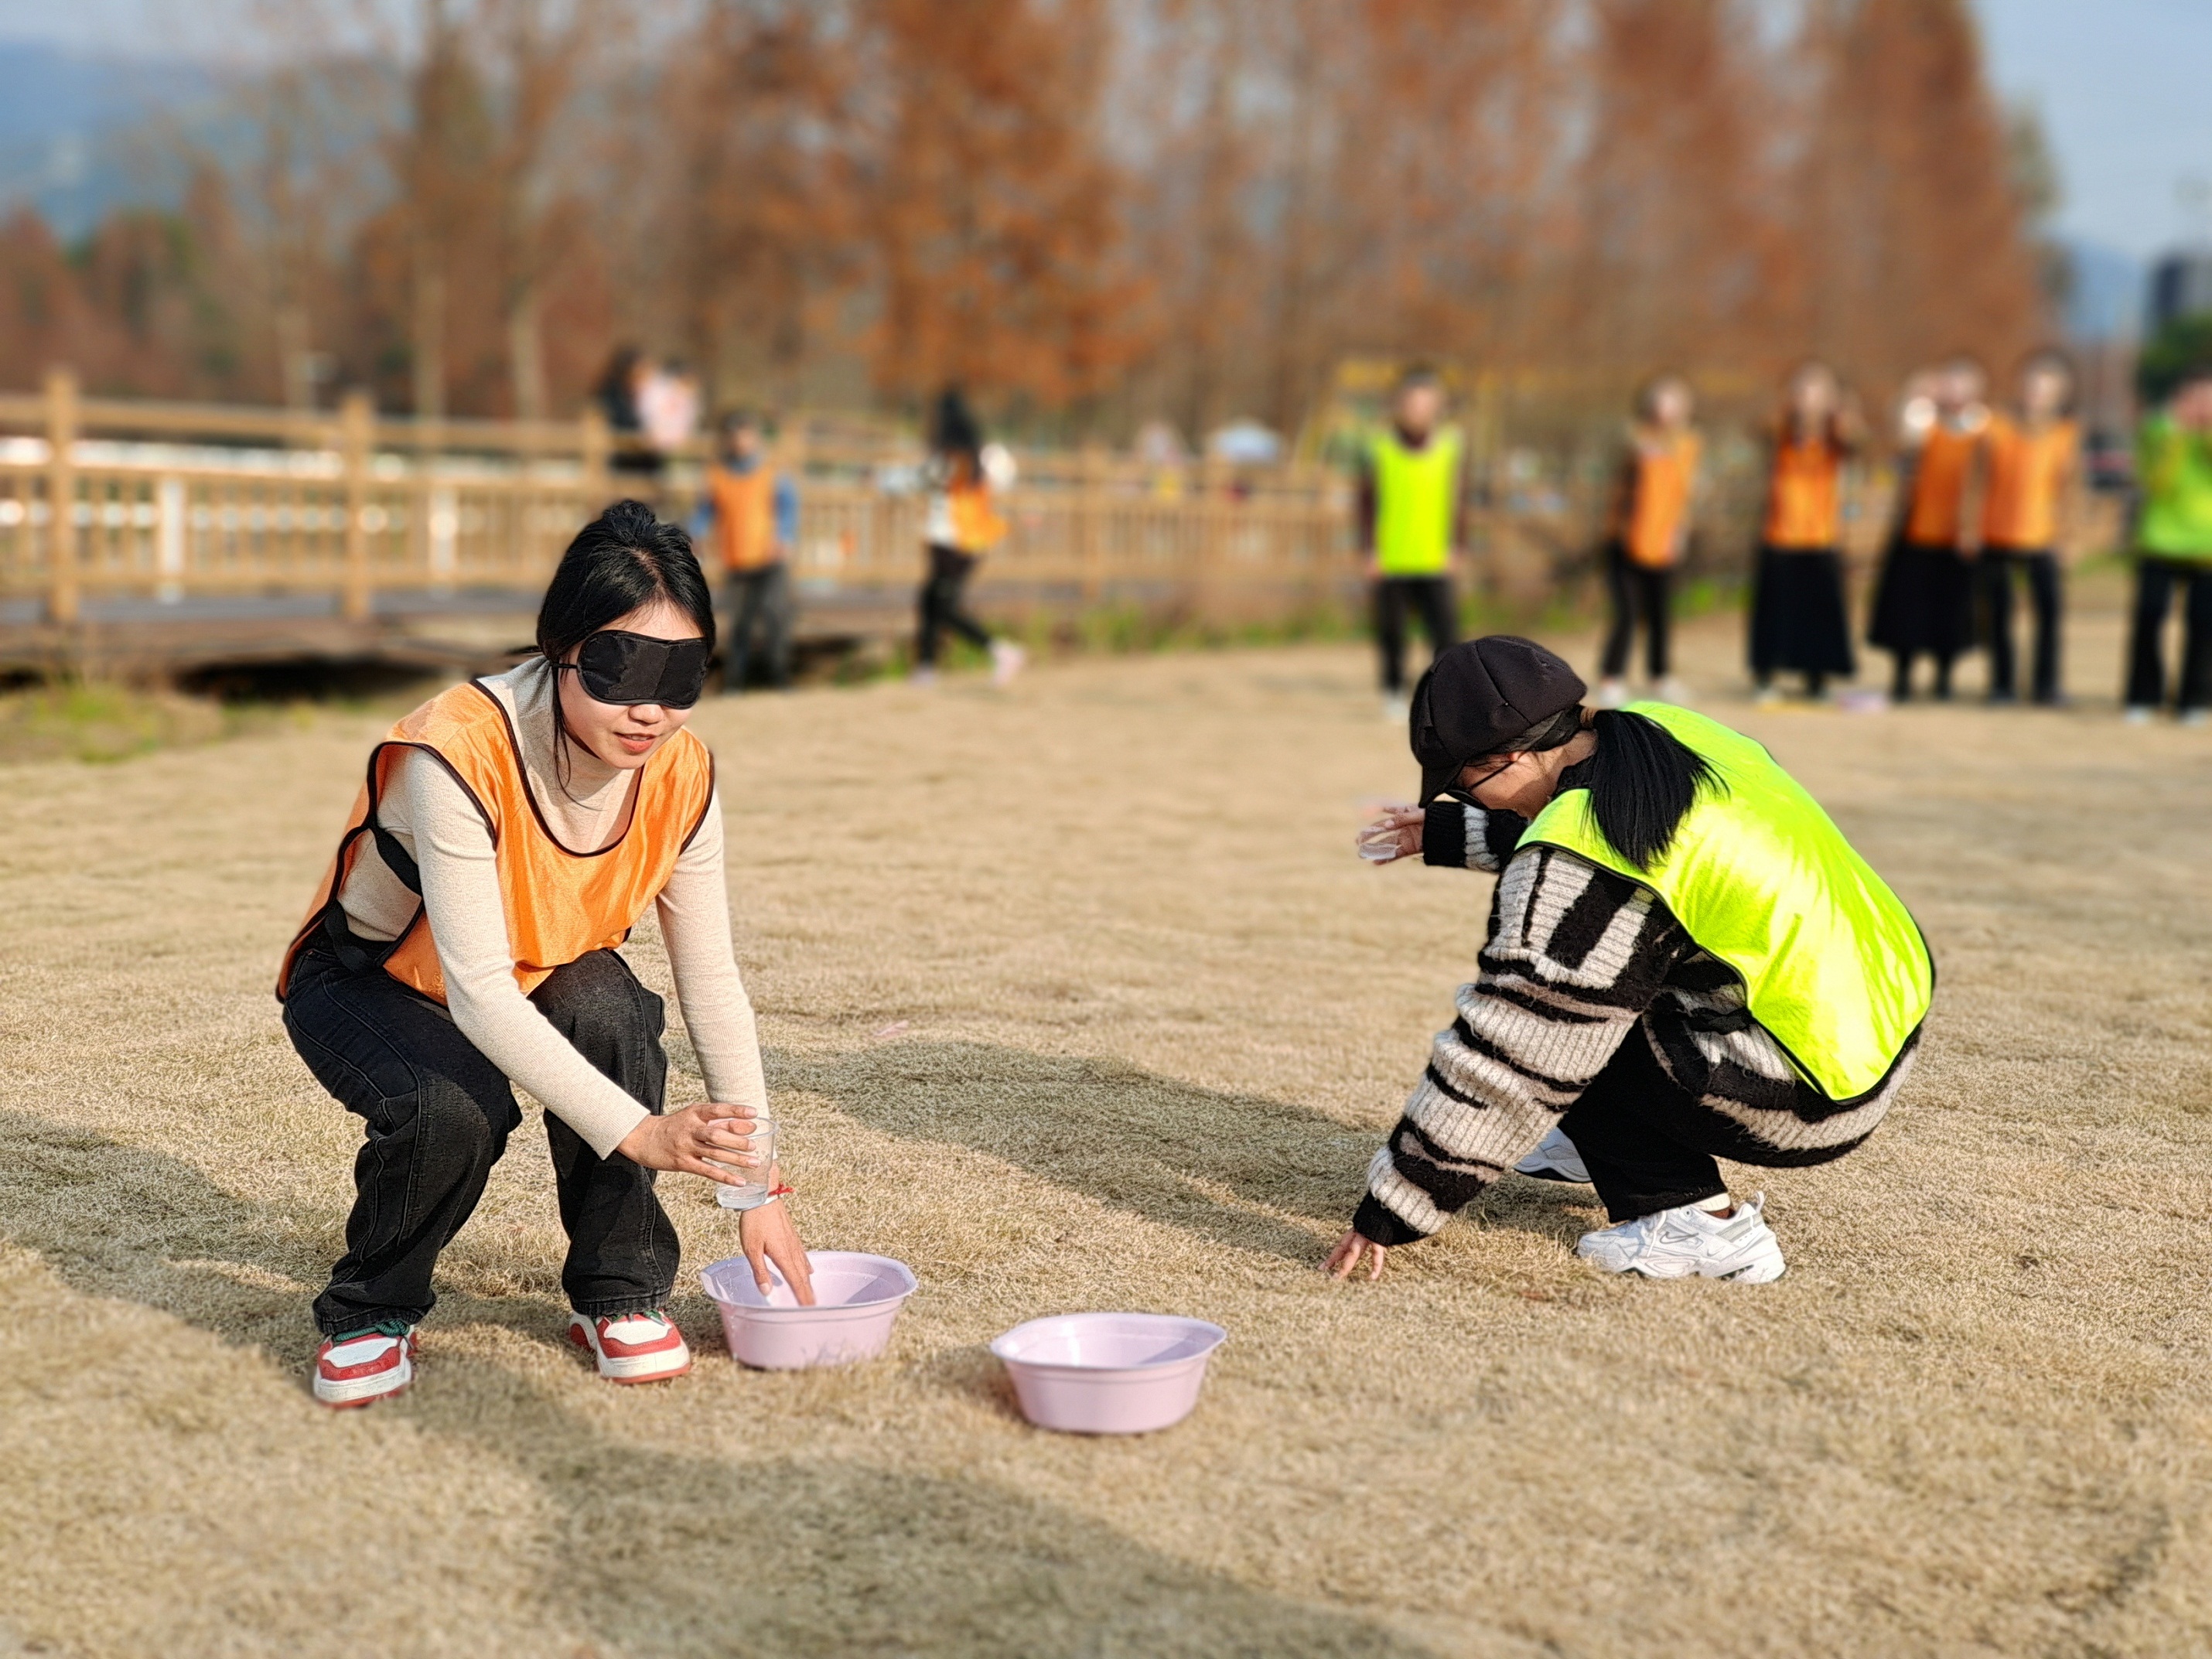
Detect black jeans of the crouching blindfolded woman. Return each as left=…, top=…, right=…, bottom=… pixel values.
left=283, top=949, right=677, bottom=1336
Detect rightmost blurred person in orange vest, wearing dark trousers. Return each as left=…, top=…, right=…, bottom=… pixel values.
left=1980, top=352, right=2081, bottom=703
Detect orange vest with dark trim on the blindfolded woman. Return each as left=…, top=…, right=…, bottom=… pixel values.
left=277, top=681, right=715, bottom=1002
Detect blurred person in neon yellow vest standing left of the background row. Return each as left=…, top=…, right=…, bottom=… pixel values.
left=1353, top=363, right=1466, bottom=721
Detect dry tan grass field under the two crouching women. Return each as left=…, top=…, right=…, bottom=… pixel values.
left=0, top=592, right=2212, bottom=1659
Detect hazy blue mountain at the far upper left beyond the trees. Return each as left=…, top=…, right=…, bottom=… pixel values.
left=0, top=39, right=224, bottom=239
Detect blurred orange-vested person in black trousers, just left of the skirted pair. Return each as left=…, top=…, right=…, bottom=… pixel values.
left=1597, top=374, right=1701, bottom=708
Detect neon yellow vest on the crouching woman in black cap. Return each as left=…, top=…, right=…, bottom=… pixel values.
left=1520, top=703, right=1936, bottom=1104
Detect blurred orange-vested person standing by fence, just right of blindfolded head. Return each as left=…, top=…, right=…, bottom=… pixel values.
left=701, top=409, right=798, bottom=697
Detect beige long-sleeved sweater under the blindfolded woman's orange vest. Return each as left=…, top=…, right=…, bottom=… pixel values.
left=339, top=657, right=767, bottom=1157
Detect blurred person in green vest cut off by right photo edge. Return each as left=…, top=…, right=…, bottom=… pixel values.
left=2125, top=360, right=2212, bottom=725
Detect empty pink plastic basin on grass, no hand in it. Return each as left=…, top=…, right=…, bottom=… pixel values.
left=991, top=1314, right=1227, bottom=1433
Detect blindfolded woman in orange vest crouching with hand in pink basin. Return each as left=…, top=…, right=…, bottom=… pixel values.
left=277, top=502, right=814, bottom=1407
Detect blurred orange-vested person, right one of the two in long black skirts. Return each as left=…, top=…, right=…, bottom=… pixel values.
left=1867, top=356, right=1988, bottom=703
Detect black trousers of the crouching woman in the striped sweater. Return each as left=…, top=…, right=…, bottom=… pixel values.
left=1559, top=1035, right=1743, bottom=1221
